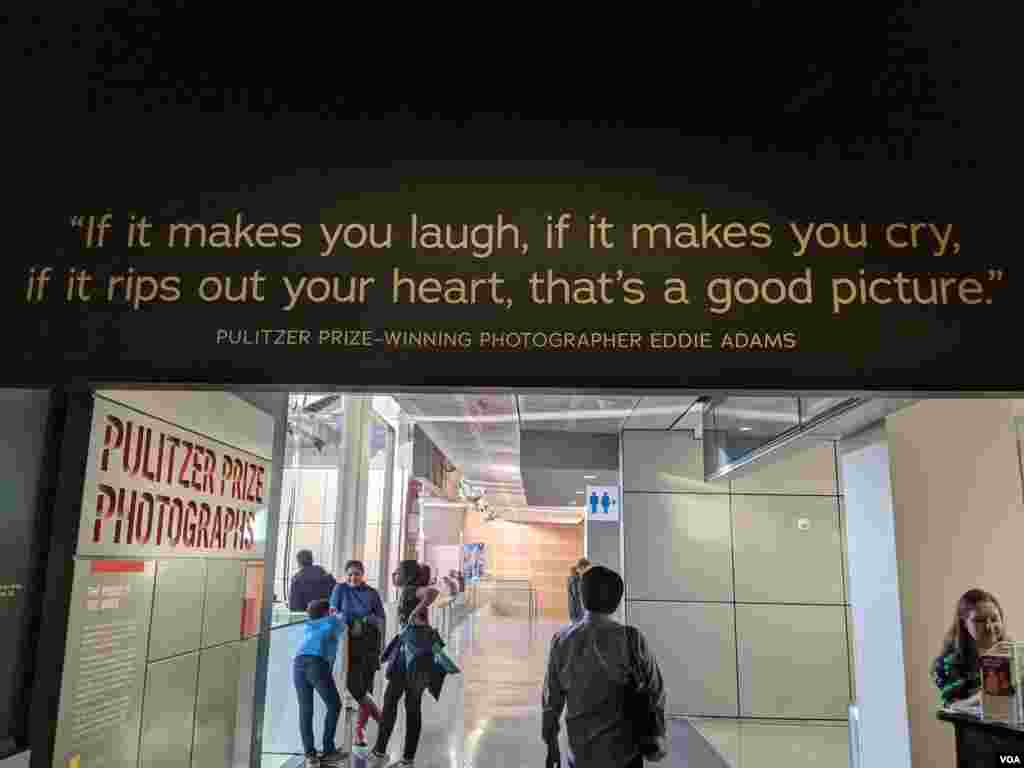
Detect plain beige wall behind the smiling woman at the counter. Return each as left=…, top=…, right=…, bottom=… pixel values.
left=887, top=399, right=1024, bottom=768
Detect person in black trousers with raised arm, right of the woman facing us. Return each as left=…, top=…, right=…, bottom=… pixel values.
left=367, top=560, right=439, bottom=768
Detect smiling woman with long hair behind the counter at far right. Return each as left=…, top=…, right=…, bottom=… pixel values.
left=932, top=589, right=1009, bottom=707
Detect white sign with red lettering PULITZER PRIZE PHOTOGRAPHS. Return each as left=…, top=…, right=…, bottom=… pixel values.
left=78, top=397, right=270, bottom=559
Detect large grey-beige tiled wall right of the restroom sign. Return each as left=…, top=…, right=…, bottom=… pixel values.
left=623, top=430, right=852, bottom=723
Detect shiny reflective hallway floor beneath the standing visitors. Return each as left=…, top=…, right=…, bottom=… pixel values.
left=263, top=614, right=849, bottom=768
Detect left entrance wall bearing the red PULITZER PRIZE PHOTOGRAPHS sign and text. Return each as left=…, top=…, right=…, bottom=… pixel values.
left=50, top=391, right=273, bottom=768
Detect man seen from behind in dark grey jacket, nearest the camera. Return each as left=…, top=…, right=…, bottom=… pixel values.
left=542, top=565, right=668, bottom=768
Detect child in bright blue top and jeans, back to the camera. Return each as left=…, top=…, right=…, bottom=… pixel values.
left=292, top=600, right=346, bottom=768
